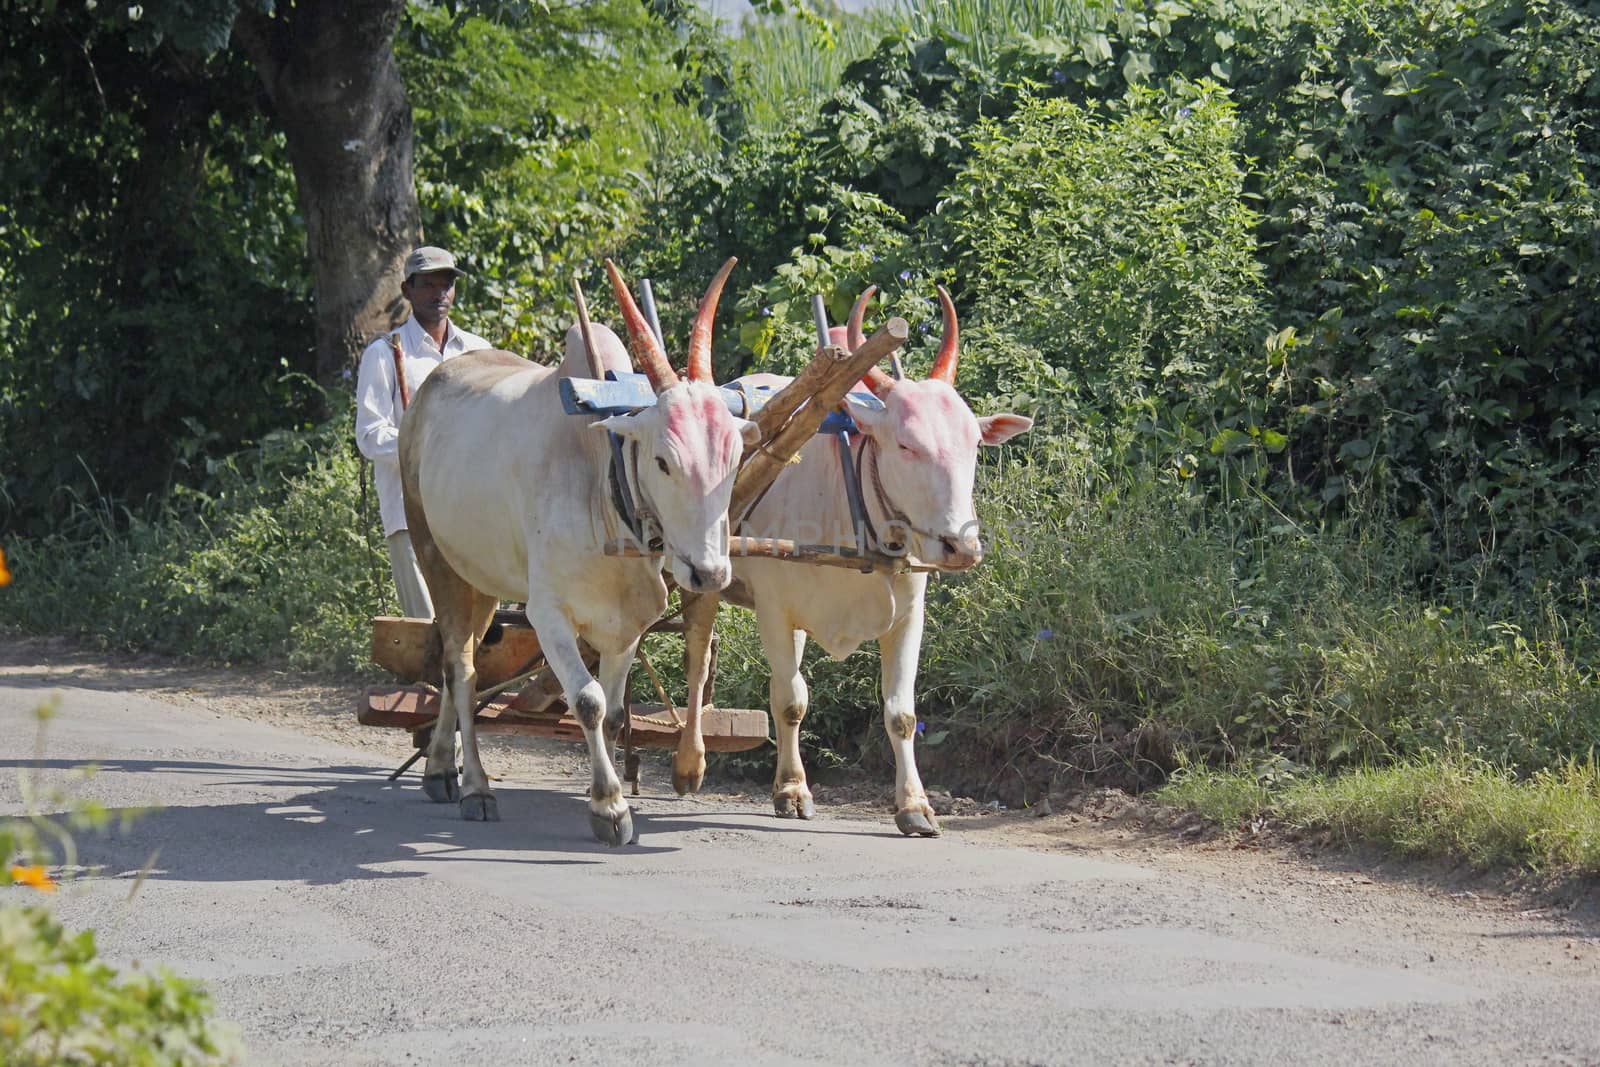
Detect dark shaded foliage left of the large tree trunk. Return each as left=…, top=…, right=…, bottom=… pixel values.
left=0, top=10, right=320, bottom=533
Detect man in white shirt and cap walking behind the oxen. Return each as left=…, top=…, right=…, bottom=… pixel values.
left=355, top=246, right=494, bottom=619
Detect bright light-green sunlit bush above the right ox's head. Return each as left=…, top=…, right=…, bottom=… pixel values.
left=941, top=86, right=1266, bottom=440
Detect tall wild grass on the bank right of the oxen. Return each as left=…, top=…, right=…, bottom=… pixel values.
left=922, top=448, right=1600, bottom=773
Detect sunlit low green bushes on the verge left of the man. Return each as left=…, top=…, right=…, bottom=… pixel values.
left=0, top=416, right=395, bottom=672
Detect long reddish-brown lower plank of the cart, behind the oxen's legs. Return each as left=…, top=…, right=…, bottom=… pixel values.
left=355, top=686, right=766, bottom=752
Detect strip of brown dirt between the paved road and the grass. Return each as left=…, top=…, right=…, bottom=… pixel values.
left=0, top=635, right=1600, bottom=977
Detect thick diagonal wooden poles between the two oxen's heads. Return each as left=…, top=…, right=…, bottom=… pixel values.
left=728, top=315, right=910, bottom=531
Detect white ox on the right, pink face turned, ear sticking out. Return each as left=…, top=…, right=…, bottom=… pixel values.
left=672, top=286, right=1034, bottom=837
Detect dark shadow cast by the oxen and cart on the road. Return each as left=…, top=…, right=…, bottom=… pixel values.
left=0, top=760, right=880, bottom=885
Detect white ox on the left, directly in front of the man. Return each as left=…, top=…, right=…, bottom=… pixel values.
left=400, top=259, right=757, bottom=845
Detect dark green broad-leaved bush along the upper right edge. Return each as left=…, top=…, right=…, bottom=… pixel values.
left=1240, top=0, right=1600, bottom=601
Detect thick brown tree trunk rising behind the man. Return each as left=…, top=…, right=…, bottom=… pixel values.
left=234, top=0, right=421, bottom=386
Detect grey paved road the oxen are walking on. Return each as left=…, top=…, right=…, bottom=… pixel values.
left=0, top=675, right=1600, bottom=1067
